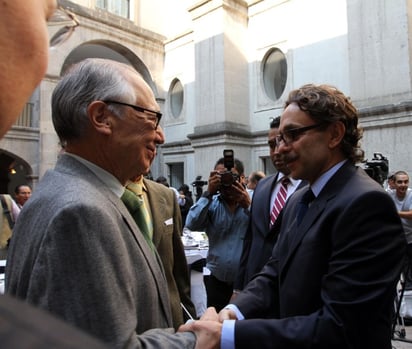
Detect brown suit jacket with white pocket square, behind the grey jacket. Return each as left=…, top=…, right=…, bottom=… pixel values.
left=144, top=179, right=196, bottom=329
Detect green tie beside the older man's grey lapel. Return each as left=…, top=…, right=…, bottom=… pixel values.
left=121, top=183, right=155, bottom=251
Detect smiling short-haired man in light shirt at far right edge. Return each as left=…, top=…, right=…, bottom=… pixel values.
left=389, top=171, right=412, bottom=290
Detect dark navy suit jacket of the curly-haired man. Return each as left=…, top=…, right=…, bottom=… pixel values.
left=234, top=163, right=406, bottom=349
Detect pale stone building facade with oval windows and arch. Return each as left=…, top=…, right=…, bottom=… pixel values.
left=0, top=0, right=412, bottom=192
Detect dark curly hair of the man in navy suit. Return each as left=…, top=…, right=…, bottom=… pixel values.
left=285, top=84, right=363, bottom=163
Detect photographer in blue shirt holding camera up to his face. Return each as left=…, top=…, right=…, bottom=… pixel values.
left=186, top=158, right=250, bottom=311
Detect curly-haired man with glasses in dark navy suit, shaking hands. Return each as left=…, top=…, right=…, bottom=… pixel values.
left=181, top=84, right=406, bottom=349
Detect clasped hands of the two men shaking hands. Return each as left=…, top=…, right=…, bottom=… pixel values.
left=178, top=307, right=237, bottom=349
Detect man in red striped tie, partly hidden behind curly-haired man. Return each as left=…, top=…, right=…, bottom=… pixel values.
left=234, top=117, right=306, bottom=294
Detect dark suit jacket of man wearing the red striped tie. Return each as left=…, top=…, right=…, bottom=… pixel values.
left=234, top=174, right=307, bottom=290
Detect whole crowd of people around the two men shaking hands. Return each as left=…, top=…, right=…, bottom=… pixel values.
left=0, top=0, right=412, bottom=349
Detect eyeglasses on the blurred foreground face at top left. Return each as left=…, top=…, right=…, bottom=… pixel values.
left=47, top=7, right=80, bottom=48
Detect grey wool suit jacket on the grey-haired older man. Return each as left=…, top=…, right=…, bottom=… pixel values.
left=6, top=154, right=195, bottom=348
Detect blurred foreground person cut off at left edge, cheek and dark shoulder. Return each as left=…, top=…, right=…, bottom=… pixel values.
left=0, top=0, right=107, bottom=349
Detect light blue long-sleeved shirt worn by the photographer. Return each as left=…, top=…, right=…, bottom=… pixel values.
left=186, top=195, right=249, bottom=283
